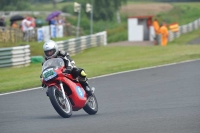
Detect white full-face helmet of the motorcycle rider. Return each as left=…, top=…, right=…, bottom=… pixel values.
left=43, top=40, right=58, bottom=59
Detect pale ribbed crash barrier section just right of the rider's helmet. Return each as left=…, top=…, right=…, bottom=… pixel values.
left=57, top=31, right=107, bottom=55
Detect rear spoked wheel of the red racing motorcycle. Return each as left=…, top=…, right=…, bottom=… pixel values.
left=83, top=94, right=98, bottom=115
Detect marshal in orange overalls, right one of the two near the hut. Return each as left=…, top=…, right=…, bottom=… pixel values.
left=160, top=21, right=169, bottom=46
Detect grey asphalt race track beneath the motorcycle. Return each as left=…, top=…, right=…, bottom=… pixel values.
left=0, top=60, right=200, bottom=133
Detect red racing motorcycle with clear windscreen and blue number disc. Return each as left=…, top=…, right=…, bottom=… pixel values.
left=42, top=58, right=98, bottom=118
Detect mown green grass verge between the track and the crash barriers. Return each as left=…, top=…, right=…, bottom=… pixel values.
left=0, top=45, right=200, bottom=93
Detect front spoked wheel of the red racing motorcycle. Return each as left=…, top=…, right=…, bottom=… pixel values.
left=48, top=86, right=72, bottom=118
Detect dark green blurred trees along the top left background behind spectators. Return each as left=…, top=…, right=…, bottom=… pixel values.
left=0, top=0, right=127, bottom=20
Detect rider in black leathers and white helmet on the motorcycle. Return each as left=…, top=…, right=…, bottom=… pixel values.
left=42, top=40, right=92, bottom=96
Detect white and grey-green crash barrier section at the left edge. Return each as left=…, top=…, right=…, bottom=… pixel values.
left=0, top=45, right=31, bottom=67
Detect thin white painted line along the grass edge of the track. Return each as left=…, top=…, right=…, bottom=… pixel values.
left=0, top=59, right=200, bottom=96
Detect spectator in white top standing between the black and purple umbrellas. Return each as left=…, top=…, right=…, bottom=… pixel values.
left=22, top=16, right=31, bottom=41
